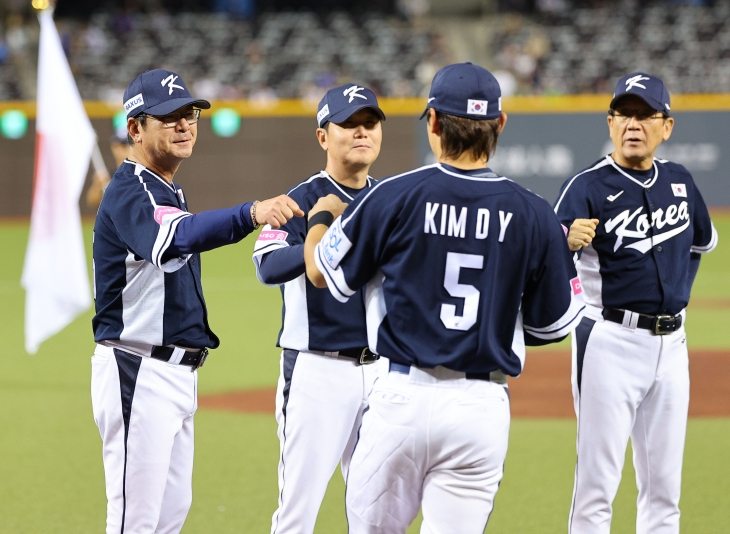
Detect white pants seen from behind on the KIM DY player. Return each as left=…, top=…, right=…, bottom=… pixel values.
left=345, top=367, right=510, bottom=534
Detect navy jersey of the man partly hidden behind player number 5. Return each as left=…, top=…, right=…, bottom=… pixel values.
left=253, top=171, right=375, bottom=352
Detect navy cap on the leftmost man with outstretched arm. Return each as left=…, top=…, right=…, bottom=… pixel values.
left=123, top=69, right=210, bottom=118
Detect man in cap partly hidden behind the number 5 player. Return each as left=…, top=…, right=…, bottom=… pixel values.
left=253, top=83, right=386, bottom=534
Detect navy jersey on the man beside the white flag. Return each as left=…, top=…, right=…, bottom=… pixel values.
left=92, top=161, right=219, bottom=352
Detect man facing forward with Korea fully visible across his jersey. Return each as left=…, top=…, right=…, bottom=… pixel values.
left=555, top=72, right=717, bottom=534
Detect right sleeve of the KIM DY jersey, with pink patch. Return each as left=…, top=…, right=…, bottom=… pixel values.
left=521, top=207, right=585, bottom=344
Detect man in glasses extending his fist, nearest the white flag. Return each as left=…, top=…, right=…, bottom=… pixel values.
left=91, top=70, right=303, bottom=534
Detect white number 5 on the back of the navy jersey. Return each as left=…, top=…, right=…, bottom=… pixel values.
left=441, top=252, right=484, bottom=331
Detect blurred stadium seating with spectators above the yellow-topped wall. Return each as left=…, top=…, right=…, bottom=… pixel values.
left=0, top=0, right=730, bottom=106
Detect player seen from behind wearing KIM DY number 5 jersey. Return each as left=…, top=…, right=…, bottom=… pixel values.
left=305, top=63, right=583, bottom=534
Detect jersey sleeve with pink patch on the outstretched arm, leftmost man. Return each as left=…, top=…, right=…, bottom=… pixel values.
left=110, top=182, right=191, bottom=273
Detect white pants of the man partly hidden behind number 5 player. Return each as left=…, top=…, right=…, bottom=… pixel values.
left=271, top=350, right=387, bottom=534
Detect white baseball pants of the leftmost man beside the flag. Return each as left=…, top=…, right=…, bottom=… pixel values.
left=91, top=345, right=198, bottom=534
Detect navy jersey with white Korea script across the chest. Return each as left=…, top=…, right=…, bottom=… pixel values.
left=555, top=156, right=717, bottom=315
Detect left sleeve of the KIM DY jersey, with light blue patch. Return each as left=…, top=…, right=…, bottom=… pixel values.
left=314, top=185, right=398, bottom=302
